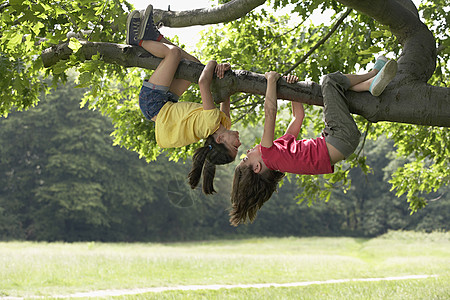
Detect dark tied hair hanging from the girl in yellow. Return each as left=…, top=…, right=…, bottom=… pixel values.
left=188, top=135, right=235, bottom=195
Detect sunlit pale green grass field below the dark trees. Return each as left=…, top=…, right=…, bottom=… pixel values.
left=0, top=232, right=450, bottom=299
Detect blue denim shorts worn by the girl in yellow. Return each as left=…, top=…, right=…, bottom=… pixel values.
left=139, top=80, right=179, bottom=120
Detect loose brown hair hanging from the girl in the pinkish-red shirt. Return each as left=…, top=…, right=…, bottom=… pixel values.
left=230, top=166, right=285, bottom=226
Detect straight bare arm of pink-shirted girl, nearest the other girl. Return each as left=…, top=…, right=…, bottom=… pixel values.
left=261, top=71, right=280, bottom=148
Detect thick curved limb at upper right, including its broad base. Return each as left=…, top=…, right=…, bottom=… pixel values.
left=338, top=0, right=450, bottom=127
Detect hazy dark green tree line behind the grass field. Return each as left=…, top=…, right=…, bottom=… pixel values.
left=0, top=84, right=450, bottom=241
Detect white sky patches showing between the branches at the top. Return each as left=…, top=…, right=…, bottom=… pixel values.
left=128, top=0, right=422, bottom=49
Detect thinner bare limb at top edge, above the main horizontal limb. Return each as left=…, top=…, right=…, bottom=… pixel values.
left=154, top=0, right=266, bottom=27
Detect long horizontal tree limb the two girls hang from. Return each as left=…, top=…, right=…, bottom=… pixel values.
left=41, top=42, right=450, bottom=127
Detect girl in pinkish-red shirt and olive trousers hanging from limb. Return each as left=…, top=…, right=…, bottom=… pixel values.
left=230, top=56, right=397, bottom=226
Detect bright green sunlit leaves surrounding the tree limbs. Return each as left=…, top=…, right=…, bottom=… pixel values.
left=0, top=0, right=450, bottom=216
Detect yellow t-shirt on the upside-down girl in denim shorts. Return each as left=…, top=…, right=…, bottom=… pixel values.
left=155, top=102, right=231, bottom=148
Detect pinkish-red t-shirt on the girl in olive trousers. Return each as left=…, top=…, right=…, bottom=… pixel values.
left=261, top=134, right=334, bottom=175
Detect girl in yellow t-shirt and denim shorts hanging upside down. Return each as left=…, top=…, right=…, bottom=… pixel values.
left=127, top=5, right=241, bottom=194
